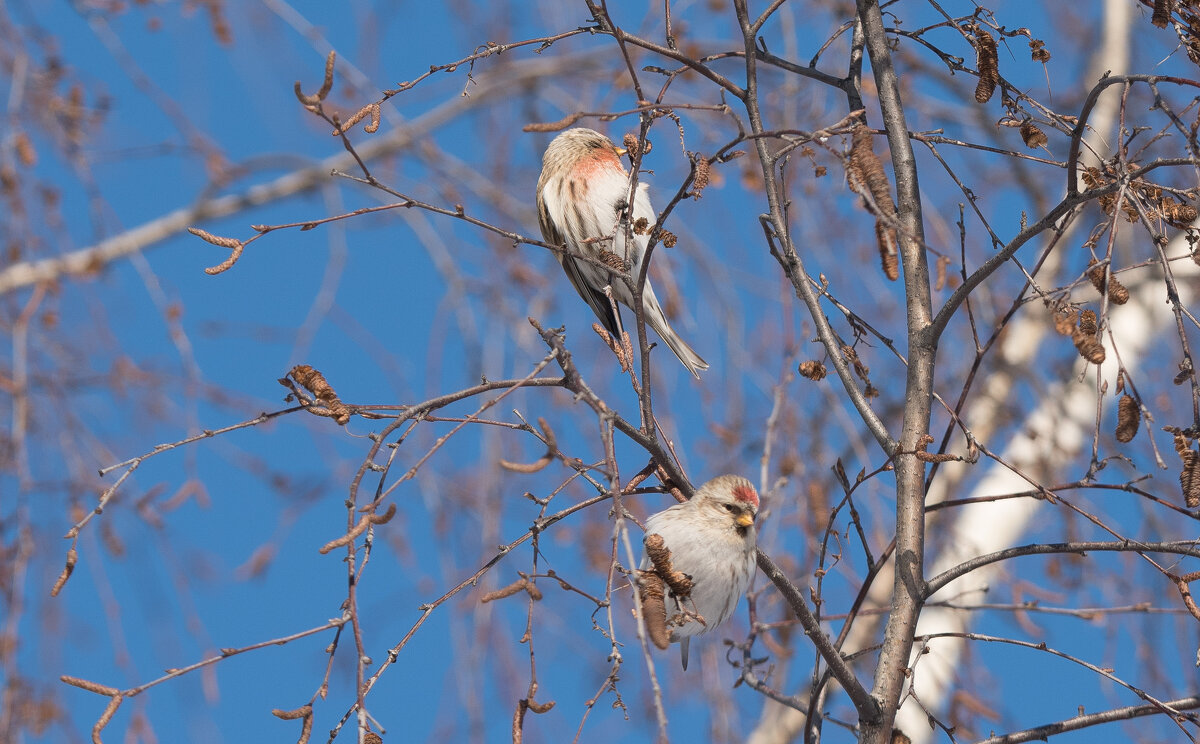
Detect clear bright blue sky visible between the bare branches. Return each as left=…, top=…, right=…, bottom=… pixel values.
left=9, top=1, right=1194, bottom=742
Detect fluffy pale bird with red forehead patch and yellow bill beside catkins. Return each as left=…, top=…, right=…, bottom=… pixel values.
left=642, top=475, right=758, bottom=670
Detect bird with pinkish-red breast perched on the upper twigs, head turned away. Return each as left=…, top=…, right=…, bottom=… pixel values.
left=538, top=127, right=708, bottom=378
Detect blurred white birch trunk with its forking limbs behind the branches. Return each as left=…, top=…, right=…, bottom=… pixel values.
left=746, top=0, right=1132, bottom=744
